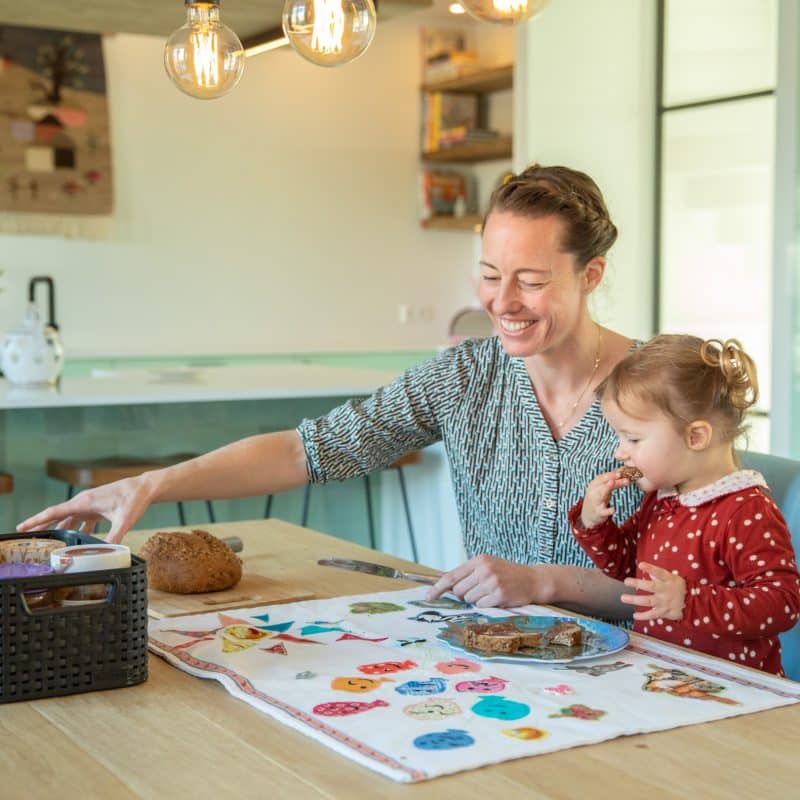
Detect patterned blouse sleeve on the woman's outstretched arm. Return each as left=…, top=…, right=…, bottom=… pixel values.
left=297, top=340, right=480, bottom=483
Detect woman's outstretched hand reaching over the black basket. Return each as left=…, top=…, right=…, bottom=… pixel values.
left=17, top=473, right=152, bottom=542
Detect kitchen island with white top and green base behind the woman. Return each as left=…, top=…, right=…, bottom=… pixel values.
left=0, top=360, right=462, bottom=568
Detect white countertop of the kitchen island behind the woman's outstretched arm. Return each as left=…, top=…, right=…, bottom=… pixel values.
left=0, top=364, right=399, bottom=409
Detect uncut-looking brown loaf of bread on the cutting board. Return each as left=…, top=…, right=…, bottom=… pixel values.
left=139, top=530, right=242, bottom=594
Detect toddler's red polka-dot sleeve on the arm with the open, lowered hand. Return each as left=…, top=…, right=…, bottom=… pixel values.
left=683, top=497, right=800, bottom=638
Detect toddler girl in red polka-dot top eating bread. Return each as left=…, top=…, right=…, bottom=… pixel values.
left=569, top=335, right=800, bottom=675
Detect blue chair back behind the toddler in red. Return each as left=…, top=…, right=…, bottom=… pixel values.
left=739, top=453, right=800, bottom=681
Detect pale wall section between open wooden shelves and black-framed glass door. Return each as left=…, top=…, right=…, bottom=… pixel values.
left=514, top=0, right=656, bottom=338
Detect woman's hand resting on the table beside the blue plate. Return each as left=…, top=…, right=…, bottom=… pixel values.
left=426, top=555, right=552, bottom=608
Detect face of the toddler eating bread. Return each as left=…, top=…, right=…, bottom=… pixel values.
left=602, top=398, right=692, bottom=492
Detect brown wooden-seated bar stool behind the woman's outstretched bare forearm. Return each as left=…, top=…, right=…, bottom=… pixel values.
left=47, top=453, right=216, bottom=525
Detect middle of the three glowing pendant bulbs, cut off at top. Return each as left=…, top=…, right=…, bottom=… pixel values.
left=283, top=0, right=376, bottom=67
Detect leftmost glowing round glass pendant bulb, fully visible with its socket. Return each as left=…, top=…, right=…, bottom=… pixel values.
left=164, top=0, right=245, bottom=100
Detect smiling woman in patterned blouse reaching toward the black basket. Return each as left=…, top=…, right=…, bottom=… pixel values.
left=19, top=165, right=640, bottom=616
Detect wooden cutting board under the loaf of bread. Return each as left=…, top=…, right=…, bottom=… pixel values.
left=147, top=574, right=314, bottom=619
